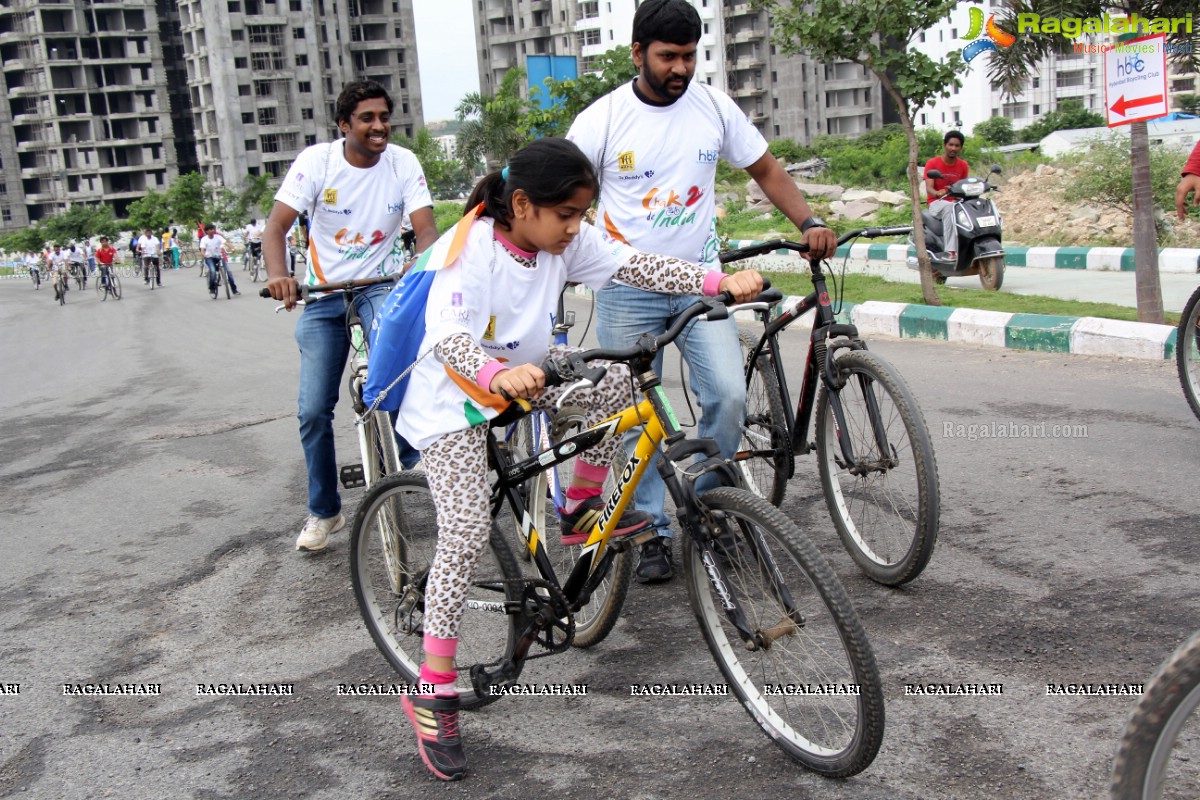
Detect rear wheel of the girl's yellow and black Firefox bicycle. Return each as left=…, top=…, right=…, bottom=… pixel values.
left=349, top=471, right=521, bottom=709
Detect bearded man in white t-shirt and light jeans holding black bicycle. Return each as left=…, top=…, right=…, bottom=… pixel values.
left=566, top=0, right=838, bottom=583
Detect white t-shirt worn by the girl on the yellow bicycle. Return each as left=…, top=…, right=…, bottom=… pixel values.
left=396, top=218, right=636, bottom=450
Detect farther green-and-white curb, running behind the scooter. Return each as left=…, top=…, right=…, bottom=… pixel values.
left=730, top=240, right=1200, bottom=273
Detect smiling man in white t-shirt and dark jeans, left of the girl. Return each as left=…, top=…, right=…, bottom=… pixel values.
left=263, top=80, right=438, bottom=552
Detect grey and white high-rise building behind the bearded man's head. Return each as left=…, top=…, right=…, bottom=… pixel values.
left=472, top=0, right=883, bottom=145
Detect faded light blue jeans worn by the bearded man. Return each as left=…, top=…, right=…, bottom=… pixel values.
left=596, top=283, right=746, bottom=536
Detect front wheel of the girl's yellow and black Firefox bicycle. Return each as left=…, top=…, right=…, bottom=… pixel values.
left=683, top=487, right=884, bottom=777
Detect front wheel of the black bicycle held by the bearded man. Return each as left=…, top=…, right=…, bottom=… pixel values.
left=816, top=350, right=941, bottom=587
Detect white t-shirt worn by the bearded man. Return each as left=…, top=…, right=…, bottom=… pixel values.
left=566, top=82, right=767, bottom=265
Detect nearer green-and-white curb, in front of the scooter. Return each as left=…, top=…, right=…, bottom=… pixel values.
left=849, top=297, right=1176, bottom=361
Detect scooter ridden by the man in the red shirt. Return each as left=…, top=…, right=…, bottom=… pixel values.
left=907, top=166, right=1004, bottom=291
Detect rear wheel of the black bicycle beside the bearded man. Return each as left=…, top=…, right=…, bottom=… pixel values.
left=736, top=331, right=794, bottom=506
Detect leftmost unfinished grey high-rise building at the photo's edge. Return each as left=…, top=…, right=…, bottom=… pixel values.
left=0, top=0, right=178, bottom=231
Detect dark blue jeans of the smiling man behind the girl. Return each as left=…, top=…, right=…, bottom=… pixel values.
left=295, top=284, right=421, bottom=517
